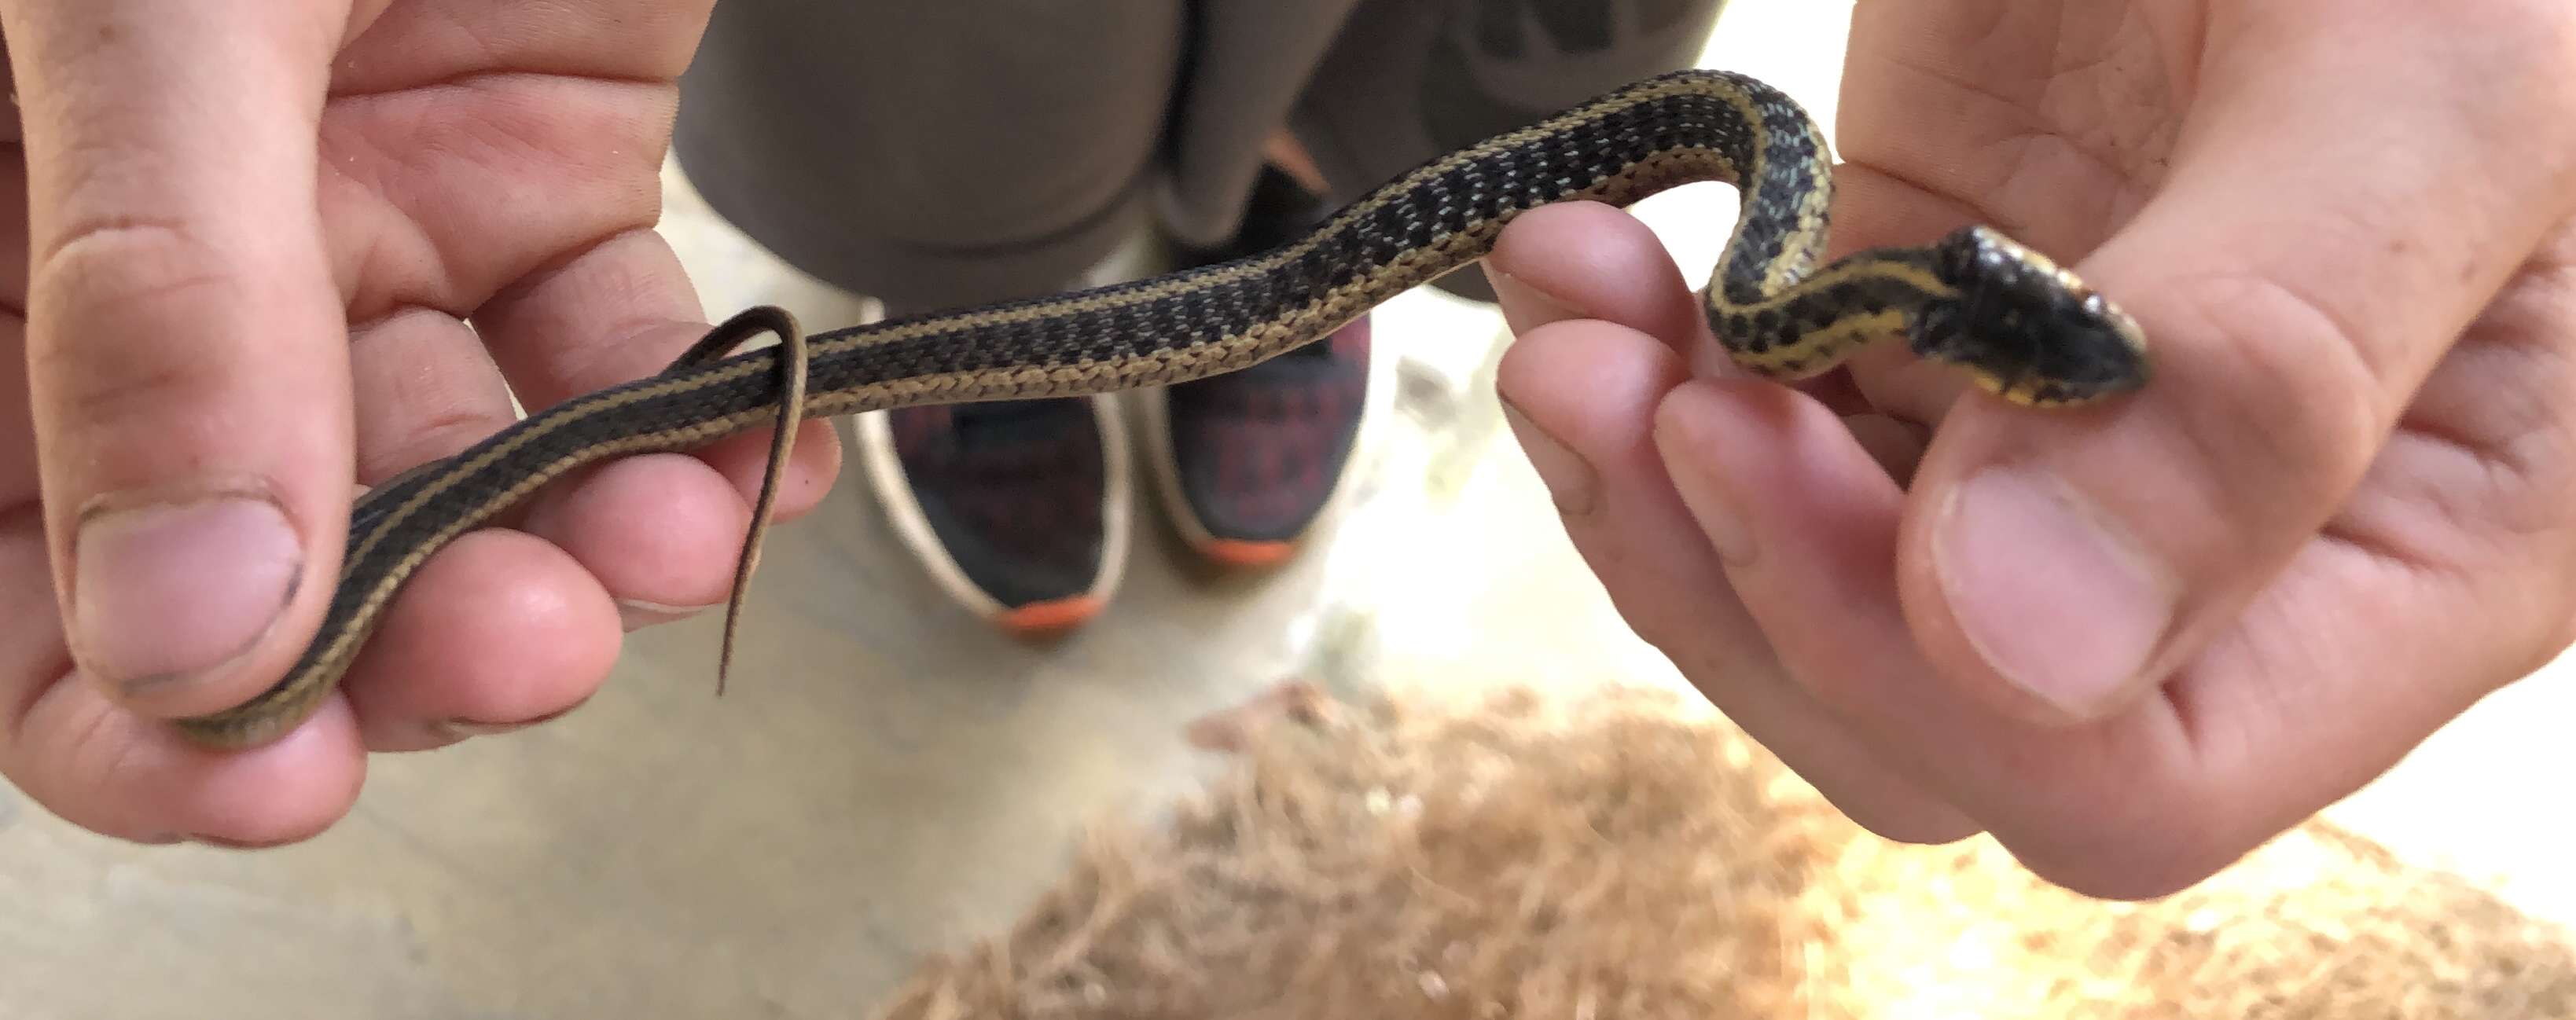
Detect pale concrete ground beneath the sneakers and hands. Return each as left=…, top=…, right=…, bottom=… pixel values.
left=0, top=0, right=2576, bottom=1020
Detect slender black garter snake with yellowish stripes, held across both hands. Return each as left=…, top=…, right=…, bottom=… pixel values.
left=178, top=70, right=2146, bottom=747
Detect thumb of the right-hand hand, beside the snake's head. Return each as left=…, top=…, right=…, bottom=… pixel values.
left=1901, top=2, right=2576, bottom=721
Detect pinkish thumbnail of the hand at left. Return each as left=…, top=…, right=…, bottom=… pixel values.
left=72, top=492, right=304, bottom=690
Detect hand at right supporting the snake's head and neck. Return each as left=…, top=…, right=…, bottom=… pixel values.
left=1486, top=0, right=2576, bottom=897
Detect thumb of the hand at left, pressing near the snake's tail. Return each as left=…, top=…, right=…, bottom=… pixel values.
left=0, top=0, right=351, bottom=714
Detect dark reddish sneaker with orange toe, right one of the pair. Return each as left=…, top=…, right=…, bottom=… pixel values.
left=1138, top=167, right=1370, bottom=569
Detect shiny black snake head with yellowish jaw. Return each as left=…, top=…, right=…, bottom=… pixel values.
left=1909, top=226, right=2146, bottom=407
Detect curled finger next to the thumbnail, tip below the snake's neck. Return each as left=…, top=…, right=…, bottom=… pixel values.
left=1656, top=381, right=2205, bottom=897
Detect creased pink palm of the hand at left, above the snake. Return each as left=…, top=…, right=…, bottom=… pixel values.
left=317, top=0, right=711, bottom=430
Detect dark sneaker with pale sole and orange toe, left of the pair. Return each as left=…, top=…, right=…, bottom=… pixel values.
left=855, top=397, right=1136, bottom=639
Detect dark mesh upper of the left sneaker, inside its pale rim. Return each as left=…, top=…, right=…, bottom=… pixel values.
left=889, top=399, right=1108, bottom=608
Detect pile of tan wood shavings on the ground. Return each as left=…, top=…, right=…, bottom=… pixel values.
left=878, top=688, right=2576, bottom=1020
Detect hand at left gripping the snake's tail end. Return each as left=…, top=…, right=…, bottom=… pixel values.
left=0, top=0, right=840, bottom=845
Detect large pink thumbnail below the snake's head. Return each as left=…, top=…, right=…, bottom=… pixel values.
left=1932, top=469, right=2177, bottom=719
